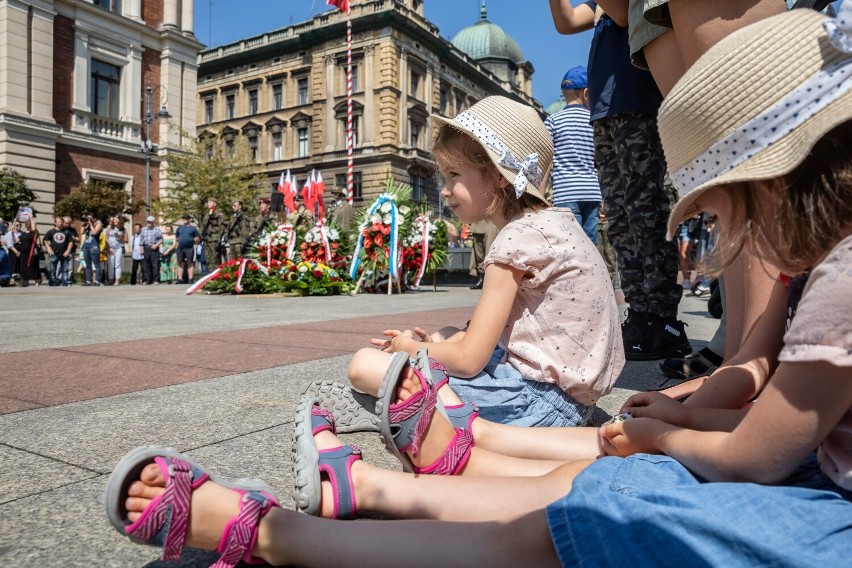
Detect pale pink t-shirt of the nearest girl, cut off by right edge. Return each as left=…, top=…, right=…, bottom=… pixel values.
left=778, top=235, right=852, bottom=490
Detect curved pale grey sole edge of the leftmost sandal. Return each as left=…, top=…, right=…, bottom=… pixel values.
left=104, top=446, right=275, bottom=546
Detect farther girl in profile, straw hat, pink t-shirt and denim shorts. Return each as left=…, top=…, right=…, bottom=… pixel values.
left=342, top=97, right=624, bottom=426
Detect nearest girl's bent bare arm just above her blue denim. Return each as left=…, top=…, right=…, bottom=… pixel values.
left=601, top=362, right=852, bottom=483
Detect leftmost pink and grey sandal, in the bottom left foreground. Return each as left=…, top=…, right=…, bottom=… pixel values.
left=106, top=446, right=281, bottom=568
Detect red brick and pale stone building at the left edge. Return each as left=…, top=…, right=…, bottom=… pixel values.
left=0, top=0, right=201, bottom=231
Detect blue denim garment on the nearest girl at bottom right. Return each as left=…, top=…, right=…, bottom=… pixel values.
left=547, top=454, right=852, bottom=568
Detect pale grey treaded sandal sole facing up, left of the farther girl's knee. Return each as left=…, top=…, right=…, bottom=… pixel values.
left=304, top=381, right=382, bottom=434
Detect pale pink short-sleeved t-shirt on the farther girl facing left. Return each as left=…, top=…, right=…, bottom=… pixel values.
left=484, top=207, right=624, bottom=405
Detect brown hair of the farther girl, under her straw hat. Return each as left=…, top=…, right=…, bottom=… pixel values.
left=432, top=124, right=547, bottom=219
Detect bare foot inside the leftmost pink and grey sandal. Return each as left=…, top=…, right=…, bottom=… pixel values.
left=125, top=463, right=280, bottom=558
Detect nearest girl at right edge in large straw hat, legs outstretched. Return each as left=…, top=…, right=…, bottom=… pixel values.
left=107, top=7, right=852, bottom=567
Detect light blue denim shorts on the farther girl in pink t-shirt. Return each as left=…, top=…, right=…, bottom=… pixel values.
left=450, top=347, right=595, bottom=426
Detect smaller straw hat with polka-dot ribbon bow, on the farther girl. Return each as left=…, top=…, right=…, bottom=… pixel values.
left=432, top=97, right=553, bottom=203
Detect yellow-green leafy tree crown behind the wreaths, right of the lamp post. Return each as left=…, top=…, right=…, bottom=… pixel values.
left=153, top=136, right=269, bottom=222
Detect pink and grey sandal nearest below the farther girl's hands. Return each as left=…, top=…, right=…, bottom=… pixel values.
left=376, top=349, right=476, bottom=475
